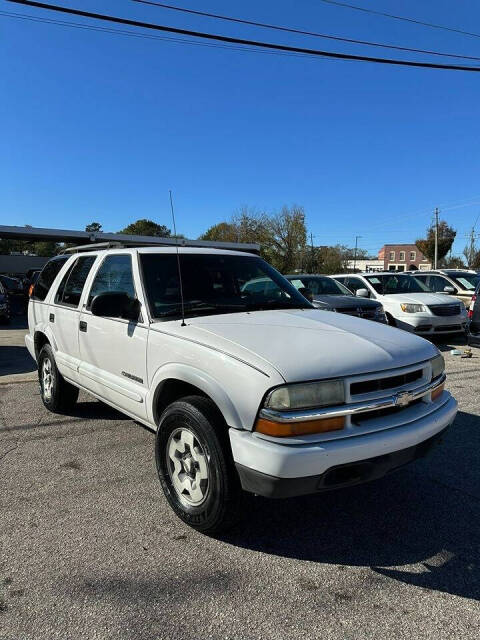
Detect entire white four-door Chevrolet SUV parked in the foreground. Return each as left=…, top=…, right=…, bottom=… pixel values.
left=25, top=247, right=457, bottom=532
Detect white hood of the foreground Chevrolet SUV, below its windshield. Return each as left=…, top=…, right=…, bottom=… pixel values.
left=167, top=309, right=438, bottom=382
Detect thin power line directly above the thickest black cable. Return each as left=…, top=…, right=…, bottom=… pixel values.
left=132, top=0, right=480, bottom=60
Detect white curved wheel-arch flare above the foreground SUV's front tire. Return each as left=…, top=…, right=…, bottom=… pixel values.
left=147, top=362, right=243, bottom=429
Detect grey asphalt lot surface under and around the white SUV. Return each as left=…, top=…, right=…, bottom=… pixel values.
left=0, top=328, right=480, bottom=640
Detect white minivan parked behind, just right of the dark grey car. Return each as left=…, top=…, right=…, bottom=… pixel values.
left=331, top=271, right=467, bottom=336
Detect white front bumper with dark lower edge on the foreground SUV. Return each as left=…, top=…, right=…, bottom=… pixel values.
left=229, top=392, right=457, bottom=497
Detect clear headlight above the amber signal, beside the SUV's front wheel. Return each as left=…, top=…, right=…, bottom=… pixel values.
left=265, top=380, right=345, bottom=411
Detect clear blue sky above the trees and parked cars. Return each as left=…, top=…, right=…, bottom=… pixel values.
left=0, top=0, right=480, bottom=253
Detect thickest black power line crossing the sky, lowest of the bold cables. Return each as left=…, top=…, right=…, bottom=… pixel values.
left=8, top=0, right=480, bottom=72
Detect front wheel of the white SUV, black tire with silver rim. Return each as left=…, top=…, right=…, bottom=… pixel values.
left=155, top=396, right=241, bottom=534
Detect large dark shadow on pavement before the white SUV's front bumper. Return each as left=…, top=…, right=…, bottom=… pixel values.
left=221, top=412, right=480, bottom=599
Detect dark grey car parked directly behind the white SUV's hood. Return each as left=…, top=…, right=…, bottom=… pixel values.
left=285, top=274, right=386, bottom=322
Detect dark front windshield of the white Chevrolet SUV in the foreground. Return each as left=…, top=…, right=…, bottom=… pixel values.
left=140, top=253, right=313, bottom=320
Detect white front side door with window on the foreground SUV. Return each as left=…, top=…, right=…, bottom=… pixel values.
left=78, top=253, right=148, bottom=418
